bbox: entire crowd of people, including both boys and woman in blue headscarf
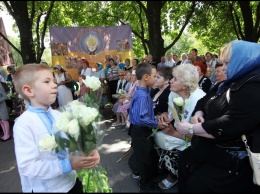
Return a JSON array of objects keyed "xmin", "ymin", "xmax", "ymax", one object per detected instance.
[{"xmin": 0, "ymin": 41, "xmax": 260, "ymax": 193}]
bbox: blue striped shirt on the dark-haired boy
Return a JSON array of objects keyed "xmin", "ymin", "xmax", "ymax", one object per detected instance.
[{"xmin": 129, "ymin": 86, "xmax": 158, "ymax": 128}]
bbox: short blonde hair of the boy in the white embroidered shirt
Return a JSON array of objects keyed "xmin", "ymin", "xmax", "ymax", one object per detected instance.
[{"xmin": 13, "ymin": 63, "xmax": 53, "ymax": 102}]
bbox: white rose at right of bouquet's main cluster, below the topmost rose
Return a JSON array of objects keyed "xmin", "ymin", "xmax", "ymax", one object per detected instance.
[{"xmin": 80, "ymin": 107, "xmax": 99, "ymax": 126}]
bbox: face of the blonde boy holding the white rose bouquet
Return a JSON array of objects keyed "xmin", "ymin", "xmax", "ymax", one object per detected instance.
[{"xmin": 30, "ymin": 70, "xmax": 58, "ymax": 110}]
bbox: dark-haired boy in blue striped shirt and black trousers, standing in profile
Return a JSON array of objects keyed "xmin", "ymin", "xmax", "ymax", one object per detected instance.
[{"xmin": 129, "ymin": 63, "xmax": 168, "ymax": 192}]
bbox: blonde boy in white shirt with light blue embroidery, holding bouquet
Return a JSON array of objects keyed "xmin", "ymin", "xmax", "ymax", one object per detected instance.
[{"xmin": 13, "ymin": 64, "xmax": 100, "ymax": 193}]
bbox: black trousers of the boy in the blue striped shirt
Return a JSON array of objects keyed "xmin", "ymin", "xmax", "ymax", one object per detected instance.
[{"xmin": 131, "ymin": 125, "xmax": 159, "ymax": 189}]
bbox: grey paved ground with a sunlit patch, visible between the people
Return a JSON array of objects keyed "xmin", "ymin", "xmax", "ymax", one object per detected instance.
[{"xmin": 0, "ymin": 109, "xmax": 177, "ymax": 193}]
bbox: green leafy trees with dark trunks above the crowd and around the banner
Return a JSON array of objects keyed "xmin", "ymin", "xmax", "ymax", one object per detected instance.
[{"xmin": 0, "ymin": 1, "xmax": 260, "ymax": 66}]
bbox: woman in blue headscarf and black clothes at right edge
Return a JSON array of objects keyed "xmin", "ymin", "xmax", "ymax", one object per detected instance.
[{"xmin": 174, "ymin": 40, "xmax": 260, "ymax": 193}]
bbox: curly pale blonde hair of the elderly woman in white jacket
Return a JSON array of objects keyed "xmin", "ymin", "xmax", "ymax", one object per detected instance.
[{"xmin": 172, "ymin": 64, "xmax": 199, "ymax": 93}]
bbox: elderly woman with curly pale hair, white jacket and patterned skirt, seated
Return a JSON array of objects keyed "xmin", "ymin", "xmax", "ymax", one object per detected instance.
[{"xmin": 155, "ymin": 64, "xmax": 206, "ymax": 189}]
